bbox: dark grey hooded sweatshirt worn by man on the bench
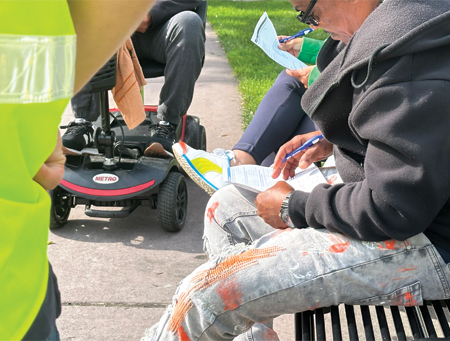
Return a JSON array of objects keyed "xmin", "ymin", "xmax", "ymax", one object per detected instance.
[{"xmin": 289, "ymin": 0, "xmax": 450, "ymax": 251}]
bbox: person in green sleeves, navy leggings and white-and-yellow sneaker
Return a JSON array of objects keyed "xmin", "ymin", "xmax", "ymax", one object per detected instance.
[{"xmin": 172, "ymin": 36, "xmax": 331, "ymax": 195}]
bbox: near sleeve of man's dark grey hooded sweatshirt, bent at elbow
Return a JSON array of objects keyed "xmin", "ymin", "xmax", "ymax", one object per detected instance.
[{"xmin": 289, "ymin": 79, "xmax": 450, "ymax": 241}]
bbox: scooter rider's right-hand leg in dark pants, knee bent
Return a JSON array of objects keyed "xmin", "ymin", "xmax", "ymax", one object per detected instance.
[{"xmin": 132, "ymin": 11, "xmax": 205, "ymax": 124}]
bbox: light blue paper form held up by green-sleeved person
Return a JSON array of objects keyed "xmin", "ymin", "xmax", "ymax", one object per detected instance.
[{"xmin": 252, "ymin": 12, "xmax": 306, "ymax": 70}]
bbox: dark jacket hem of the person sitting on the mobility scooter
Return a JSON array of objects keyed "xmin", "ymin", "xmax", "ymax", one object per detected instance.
[{"xmin": 148, "ymin": 0, "xmax": 202, "ymax": 30}]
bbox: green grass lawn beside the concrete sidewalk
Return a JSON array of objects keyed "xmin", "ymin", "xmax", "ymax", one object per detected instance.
[{"xmin": 208, "ymin": 0, "xmax": 327, "ymax": 129}]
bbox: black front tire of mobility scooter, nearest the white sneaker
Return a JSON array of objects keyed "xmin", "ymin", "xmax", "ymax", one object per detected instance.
[{"xmin": 158, "ymin": 172, "xmax": 188, "ymax": 232}]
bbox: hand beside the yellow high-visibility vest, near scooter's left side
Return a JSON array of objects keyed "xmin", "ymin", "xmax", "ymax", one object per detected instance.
[{"xmin": 33, "ymin": 131, "xmax": 66, "ymax": 190}]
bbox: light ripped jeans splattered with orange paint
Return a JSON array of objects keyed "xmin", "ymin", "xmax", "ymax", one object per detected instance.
[{"xmin": 143, "ymin": 186, "xmax": 450, "ymax": 341}]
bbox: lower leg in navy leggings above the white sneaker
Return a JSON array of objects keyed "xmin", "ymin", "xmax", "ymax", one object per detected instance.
[{"xmin": 232, "ymin": 70, "xmax": 314, "ymax": 164}]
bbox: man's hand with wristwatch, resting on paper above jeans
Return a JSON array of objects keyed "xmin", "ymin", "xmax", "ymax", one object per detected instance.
[{"xmin": 255, "ymin": 181, "xmax": 294, "ymax": 229}]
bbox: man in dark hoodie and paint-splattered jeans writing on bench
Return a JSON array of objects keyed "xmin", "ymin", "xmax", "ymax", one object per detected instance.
[{"xmin": 142, "ymin": 0, "xmax": 450, "ymax": 341}]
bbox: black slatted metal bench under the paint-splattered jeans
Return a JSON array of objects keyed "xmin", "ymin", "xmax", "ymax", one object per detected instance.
[{"xmin": 295, "ymin": 300, "xmax": 450, "ymax": 341}]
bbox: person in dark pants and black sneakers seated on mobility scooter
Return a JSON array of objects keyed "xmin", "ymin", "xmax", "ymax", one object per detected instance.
[{"xmin": 62, "ymin": 0, "xmax": 205, "ymax": 151}]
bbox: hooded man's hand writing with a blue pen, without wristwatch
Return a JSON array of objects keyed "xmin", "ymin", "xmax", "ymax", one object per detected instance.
[{"xmin": 272, "ymin": 130, "xmax": 333, "ymax": 180}]
